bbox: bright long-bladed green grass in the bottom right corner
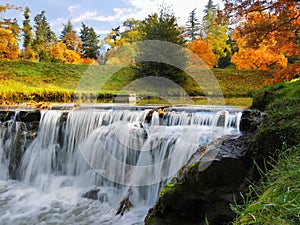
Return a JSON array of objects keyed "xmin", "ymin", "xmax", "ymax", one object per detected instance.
[{"xmin": 233, "ymin": 145, "xmax": 300, "ymax": 225}]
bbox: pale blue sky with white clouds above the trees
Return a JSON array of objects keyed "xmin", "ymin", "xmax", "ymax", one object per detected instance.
[{"xmin": 4, "ymin": 0, "xmax": 222, "ymax": 38}]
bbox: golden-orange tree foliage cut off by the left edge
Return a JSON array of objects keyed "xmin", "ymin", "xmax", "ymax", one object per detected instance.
[{"xmin": 0, "ymin": 27, "xmax": 20, "ymax": 59}]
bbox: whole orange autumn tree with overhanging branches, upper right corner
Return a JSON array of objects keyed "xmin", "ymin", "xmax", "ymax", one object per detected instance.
[{"xmin": 224, "ymin": 0, "xmax": 300, "ymax": 78}]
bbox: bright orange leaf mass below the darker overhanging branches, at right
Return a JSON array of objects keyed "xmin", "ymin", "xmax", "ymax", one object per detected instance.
[{"xmin": 231, "ymin": 12, "xmax": 299, "ymax": 70}]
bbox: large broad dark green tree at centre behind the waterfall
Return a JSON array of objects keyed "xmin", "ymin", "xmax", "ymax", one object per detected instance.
[{"xmin": 136, "ymin": 7, "xmax": 187, "ymax": 83}]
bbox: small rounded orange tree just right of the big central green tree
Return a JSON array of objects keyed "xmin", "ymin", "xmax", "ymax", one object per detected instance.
[{"xmin": 188, "ymin": 39, "xmax": 217, "ymax": 68}]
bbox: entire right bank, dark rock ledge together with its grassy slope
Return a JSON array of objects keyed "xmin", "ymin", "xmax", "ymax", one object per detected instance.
[{"xmin": 145, "ymin": 80, "xmax": 300, "ymax": 225}]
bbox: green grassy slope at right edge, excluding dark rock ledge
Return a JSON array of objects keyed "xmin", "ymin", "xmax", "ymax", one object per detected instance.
[{"xmin": 233, "ymin": 79, "xmax": 300, "ymax": 225}]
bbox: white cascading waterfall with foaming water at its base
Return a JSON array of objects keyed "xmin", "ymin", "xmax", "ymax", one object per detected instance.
[{"xmin": 0, "ymin": 109, "xmax": 241, "ymax": 225}]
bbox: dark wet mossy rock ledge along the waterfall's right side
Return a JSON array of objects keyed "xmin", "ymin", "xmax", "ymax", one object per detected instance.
[{"xmin": 145, "ymin": 110, "xmax": 262, "ymax": 225}]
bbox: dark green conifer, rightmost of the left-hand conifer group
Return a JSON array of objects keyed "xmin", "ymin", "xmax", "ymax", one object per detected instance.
[{"xmin": 80, "ymin": 23, "xmax": 100, "ymax": 59}]
